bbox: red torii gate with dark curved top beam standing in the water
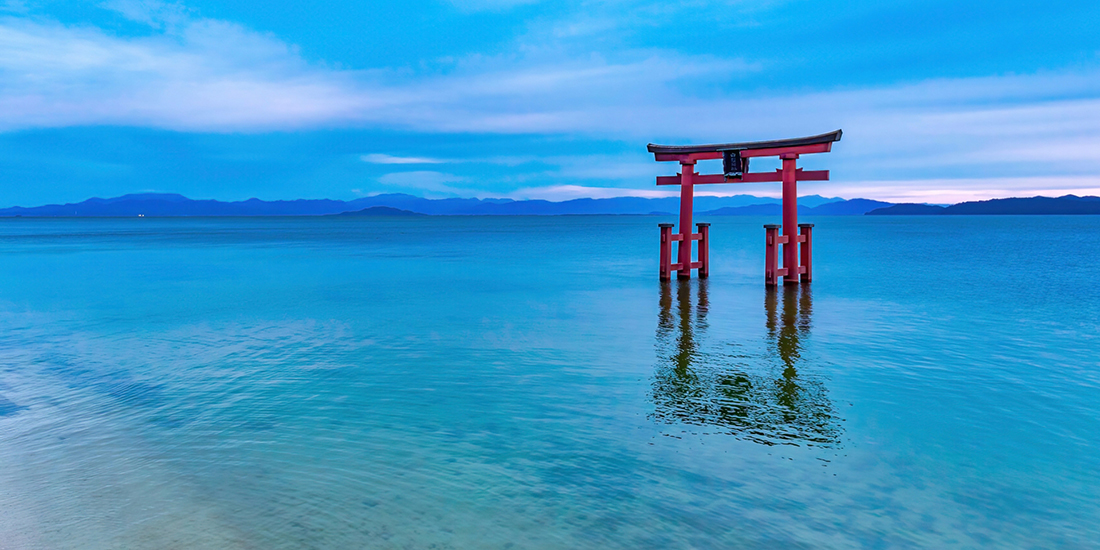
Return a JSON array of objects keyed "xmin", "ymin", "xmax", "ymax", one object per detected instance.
[{"xmin": 648, "ymin": 130, "xmax": 843, "ymax": 285}]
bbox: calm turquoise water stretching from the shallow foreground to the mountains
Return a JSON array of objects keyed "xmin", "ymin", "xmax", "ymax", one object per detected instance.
[{"xmin": 0, "ymin": 217, "xmax": 1100, "ymax": 549}]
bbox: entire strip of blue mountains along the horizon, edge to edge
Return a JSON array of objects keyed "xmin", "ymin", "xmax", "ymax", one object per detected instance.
[{"xmin": 0, "ymin": 194, "xmax": 1100, "ymax": 218}]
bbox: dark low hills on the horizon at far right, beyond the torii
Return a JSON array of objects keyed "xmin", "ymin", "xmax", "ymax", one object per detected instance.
[{"xmin": 867, "ymin": 195, "xmax": 1100, "ymax": 216}]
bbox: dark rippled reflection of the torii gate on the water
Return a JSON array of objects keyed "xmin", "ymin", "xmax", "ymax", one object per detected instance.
[{"xmin": 652, "ymin": 279, "xmax": 840, "ymax": 446}]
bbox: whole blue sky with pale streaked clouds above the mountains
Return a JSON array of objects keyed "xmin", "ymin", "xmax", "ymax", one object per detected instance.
[{"xmin": 0, "ymin": 0, "xmax": 1100, "ymax": 206}]
